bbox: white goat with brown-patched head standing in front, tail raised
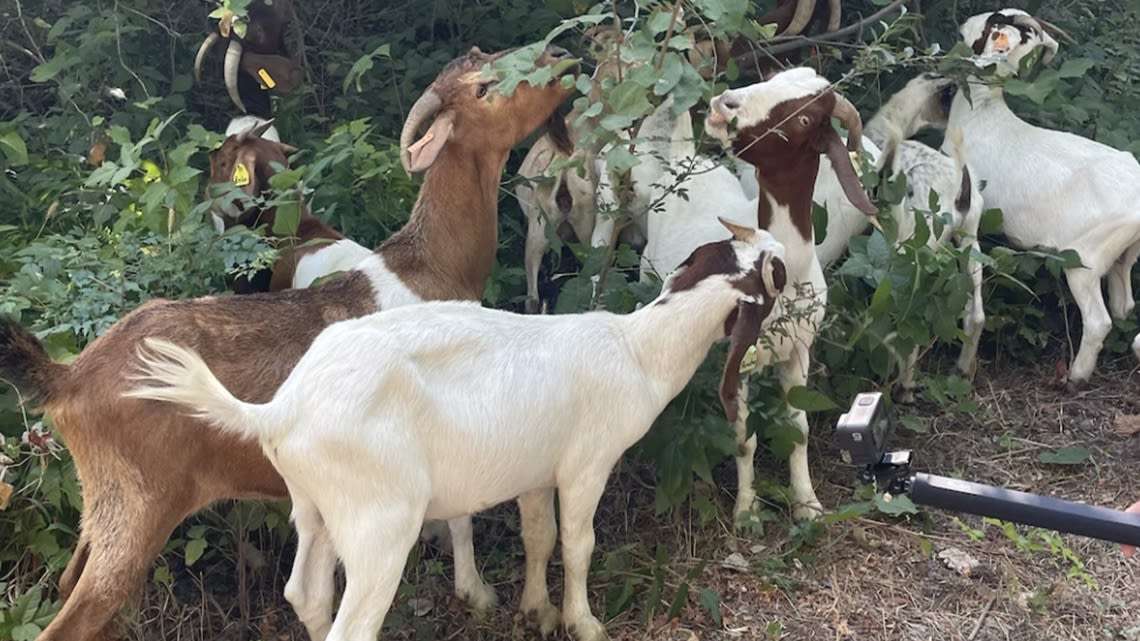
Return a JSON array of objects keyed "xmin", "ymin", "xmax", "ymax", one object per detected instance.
[{"xmin": 127, "ymin": 217, "xmax": 784, "ymax": 641}]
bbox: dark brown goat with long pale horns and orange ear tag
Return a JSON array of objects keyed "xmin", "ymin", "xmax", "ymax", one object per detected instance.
[{"xmin": 194, "ymin": 0, "xmax": 304, "ymax": 117}]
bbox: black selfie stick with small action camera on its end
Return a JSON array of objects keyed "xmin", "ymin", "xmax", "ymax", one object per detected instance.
[{"xmin": 836, "ymin": 392, "xmax": 1140, "ymax": 546}]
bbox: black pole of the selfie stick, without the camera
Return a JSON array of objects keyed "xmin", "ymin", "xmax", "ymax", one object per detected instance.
[{"xmin": 906, "ymin": 472, "xmax": 1140, "ymax": 545}]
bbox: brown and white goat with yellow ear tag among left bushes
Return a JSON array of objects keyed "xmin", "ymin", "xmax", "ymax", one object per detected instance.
[{"xmin": 206, "ymin": 121, "xmax": 372, "ymax": 293}]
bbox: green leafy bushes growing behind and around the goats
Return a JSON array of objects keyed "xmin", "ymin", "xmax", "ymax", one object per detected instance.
[{"xmin": 0, "ymin": 0, "xmax": 1140, "ymax": 640}]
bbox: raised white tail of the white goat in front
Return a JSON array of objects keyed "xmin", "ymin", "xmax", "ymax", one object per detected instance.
[{"xmin": 123, "ymin": 338, "xmax": 277, "ymax": 439}]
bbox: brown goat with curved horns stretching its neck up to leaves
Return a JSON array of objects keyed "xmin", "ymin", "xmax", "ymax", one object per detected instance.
[{"xmin": 0, "ymin": 47, "xmax": 570, "ymax": 641}]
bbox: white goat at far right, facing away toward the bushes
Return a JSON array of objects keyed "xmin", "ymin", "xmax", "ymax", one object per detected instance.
[{"xmin": 943, "ymin": 9, "xmax": 1140, "ymax": 384}]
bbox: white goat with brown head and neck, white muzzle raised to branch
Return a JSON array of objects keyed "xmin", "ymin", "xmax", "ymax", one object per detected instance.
[{"xmin": 642, "ymin": 68, "xmax": 874, "ymax": 521}]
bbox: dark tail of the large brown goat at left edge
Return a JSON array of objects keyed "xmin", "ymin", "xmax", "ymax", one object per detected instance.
[{"xmin": 0, "ymin": 316, "xmax": 70, "ymax": 406}]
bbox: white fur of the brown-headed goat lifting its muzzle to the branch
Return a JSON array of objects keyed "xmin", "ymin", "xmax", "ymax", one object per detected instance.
[{"xmin": 635, "ymin": 68, "xmax": 866, "ymax": 521}]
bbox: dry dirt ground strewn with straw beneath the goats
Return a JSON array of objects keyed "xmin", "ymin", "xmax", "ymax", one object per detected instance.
[{"xmin": 130, "ymin": 346, "xmax": 1140, "ymax": 641}]
